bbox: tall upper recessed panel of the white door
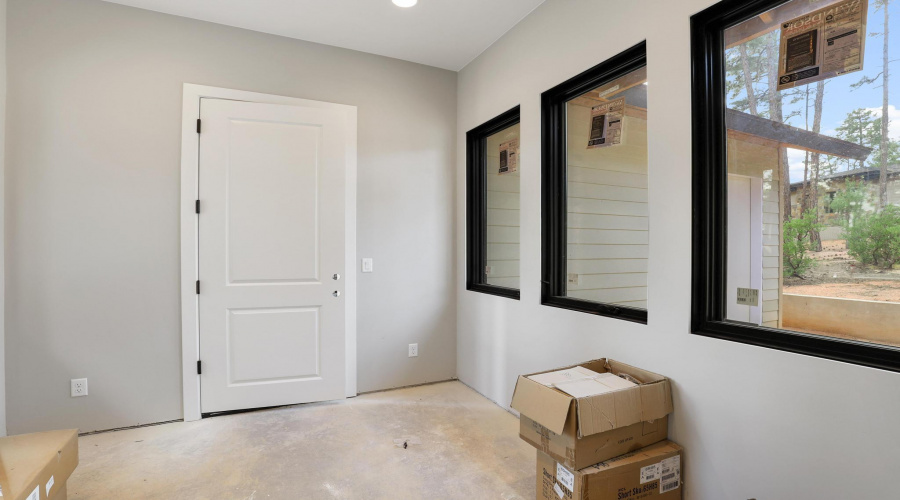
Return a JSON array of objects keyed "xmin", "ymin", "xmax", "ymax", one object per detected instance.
[{"xmin": 226, "ymin": 119, "xmax": 322, "ymax": 284}]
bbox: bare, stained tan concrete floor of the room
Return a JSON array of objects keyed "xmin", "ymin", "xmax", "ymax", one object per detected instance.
[{"xmin": 68, "ymin": 382, "xmax": 535, "ymax": 500}]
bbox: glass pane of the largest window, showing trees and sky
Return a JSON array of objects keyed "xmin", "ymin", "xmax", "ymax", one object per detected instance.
[{"xmin": 725, "ymin": 0, "xmax": 900, "ymax": 346}]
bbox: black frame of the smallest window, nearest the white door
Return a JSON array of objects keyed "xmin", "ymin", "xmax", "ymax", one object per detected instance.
[{"xmin": 466, "ymin": 106, "xmax": 521, "ymax": 300}]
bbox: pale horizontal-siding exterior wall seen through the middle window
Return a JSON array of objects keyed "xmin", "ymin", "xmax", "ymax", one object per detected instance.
[{"xmin": 566, "ymin": 108, "xmax": 650, "ymax": 308}]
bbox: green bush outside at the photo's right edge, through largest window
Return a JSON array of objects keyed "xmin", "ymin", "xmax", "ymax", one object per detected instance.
[{"xmin": 845, "ymin": 205, "xmax": 900, "ymax": 269}]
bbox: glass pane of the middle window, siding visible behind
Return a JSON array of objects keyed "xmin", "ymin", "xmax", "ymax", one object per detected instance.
[{"xmin": 565, "ymin": 67, "xmax": 649, "ymax": 309}]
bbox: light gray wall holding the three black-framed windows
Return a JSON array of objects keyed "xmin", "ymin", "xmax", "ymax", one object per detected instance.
[{"xmin": 456, "ymin": 0, "xmax": 900, "ymax": 500}]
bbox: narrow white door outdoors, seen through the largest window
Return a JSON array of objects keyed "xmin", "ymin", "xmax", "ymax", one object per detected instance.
[{"xmin": 726, "ymin": 175, "xmax": 763, "ymax": 325}]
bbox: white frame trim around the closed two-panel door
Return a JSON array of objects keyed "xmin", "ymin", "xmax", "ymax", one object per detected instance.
[{"xmin": 181, "ymin": 83, "xmax": 357, "ymax": 421}]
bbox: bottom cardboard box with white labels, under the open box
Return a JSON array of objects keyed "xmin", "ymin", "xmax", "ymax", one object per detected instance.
[{"xmin": 537, "ymin": 441, "xmax": 683, "ymax": 500}]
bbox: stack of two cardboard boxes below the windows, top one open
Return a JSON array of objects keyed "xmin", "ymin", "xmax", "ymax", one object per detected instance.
[{"xmin": 511, "ymin": 358, "xmax": 681, "ymax": 500}]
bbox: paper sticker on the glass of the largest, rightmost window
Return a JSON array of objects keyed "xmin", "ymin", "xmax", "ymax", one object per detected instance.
[{"xmin": 778, "ymin": 0, "xmax": 869, "ymax": 90}]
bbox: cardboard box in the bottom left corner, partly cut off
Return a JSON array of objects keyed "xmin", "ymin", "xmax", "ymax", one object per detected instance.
[{"xmin": 0, "ymin": 429, "xmax": 78, "ymax": 500}]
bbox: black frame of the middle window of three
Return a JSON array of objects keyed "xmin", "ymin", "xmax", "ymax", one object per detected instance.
[{"xmin": 541, "ymin": 41, "xmax": 649, "ymax": 324}]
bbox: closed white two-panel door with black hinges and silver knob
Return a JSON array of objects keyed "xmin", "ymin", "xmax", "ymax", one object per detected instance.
[{"xmin": 198, "ymin": 98, "xmax": 349, "ymax": 413}]
